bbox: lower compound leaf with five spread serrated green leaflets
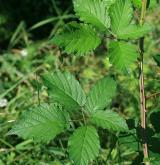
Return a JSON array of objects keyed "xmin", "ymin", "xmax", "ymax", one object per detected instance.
[{"xmin": 9, "ymin": 72, "xmax": 128, "ymax": 164}]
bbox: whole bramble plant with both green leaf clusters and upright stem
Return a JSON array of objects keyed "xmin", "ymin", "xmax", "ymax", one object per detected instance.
[{"xmin": 9, "ymin": 0, "xmax": 158, "ymax": 165}]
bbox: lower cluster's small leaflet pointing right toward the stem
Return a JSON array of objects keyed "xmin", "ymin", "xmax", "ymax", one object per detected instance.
[{"xmin": 90, "ymin": 110, "xmax": 128, "ymax": 131}]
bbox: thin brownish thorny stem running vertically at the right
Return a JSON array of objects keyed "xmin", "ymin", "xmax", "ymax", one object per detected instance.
[{"xmin": 139, "ymin": 0, "xmax": 150, "ymax": 165}]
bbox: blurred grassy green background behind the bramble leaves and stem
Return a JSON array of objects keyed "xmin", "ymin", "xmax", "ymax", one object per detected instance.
[{"xmin": 0, "ymin": 0, "xmax": 160, "ymax": 165}]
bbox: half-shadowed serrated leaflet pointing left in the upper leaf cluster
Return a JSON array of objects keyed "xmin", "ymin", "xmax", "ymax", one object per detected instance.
[{"xmin": 53, "ymin": 23, "xmax": 101, "ymax": 55}]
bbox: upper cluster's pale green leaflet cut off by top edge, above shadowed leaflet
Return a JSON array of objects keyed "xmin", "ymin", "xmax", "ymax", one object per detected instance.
[{"xmin": 74, "ymin": 0, "xmax": 110, "ymax": 31}]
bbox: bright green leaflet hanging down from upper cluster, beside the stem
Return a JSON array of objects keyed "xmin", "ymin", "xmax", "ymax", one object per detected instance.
[{"xmin": 109, "ymin": 41, "xmax": 138, "ymax": 72}]
